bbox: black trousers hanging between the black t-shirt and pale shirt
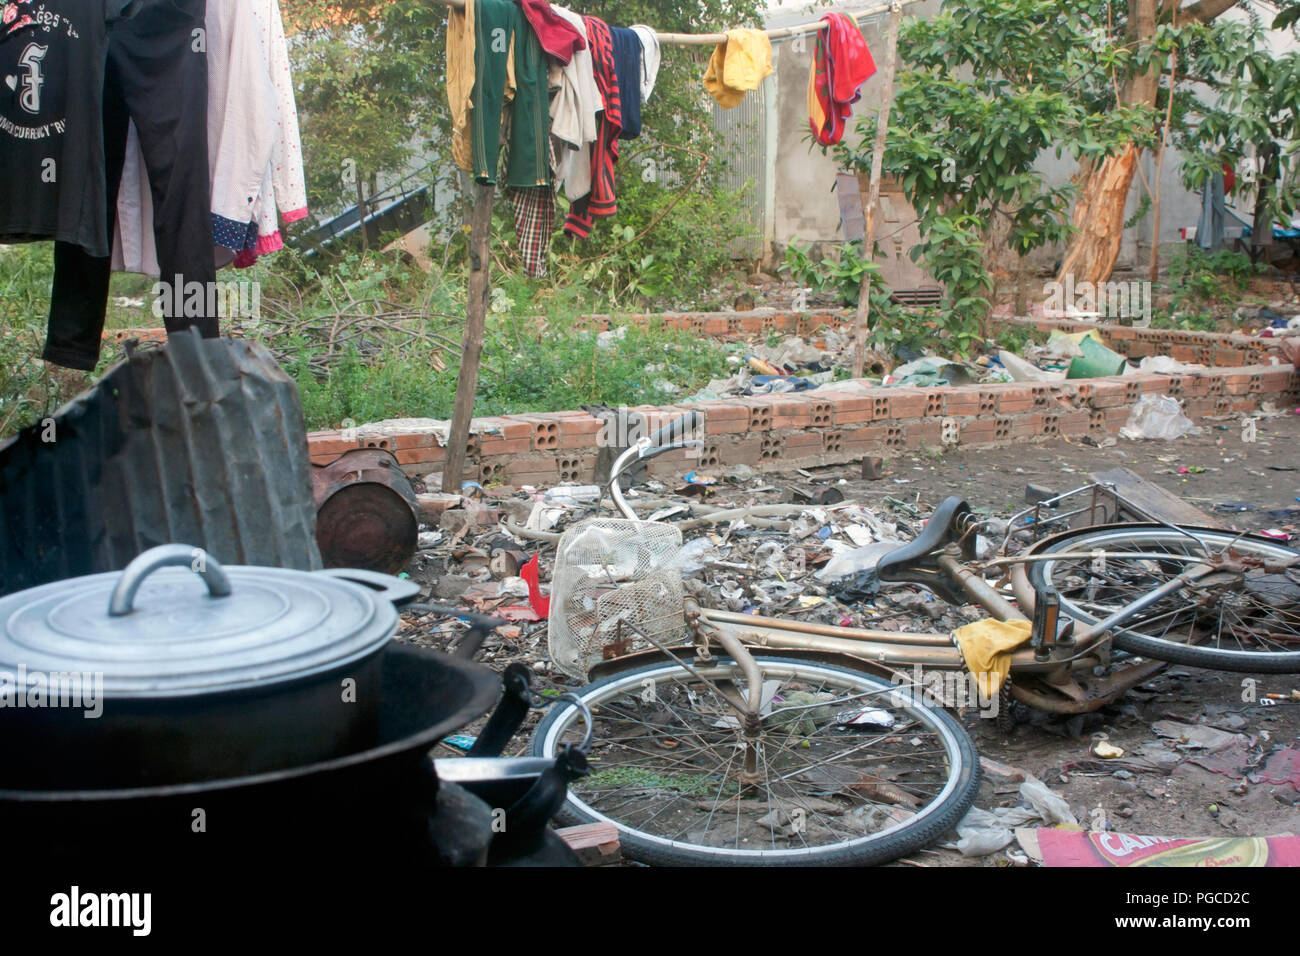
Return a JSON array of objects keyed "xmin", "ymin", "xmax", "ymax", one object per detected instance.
[{"xmin": 43, "ymin": 0, "xmax": 218, "ymax": 371}]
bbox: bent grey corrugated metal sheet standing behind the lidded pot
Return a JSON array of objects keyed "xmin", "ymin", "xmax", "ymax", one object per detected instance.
[{"xmin": 0, "ymin": 332, "xmax": 321, "ymax": 594}]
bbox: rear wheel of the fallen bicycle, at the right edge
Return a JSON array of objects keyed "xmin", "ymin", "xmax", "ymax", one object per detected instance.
[{"xmin": 1028, "ymin": 524, "xmax": 1300, "ymax": 674}]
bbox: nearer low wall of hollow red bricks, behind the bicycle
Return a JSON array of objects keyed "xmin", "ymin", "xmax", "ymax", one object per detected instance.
[{"xmin": 308, "ymin": 356, "xmax": 1300, "ymax": 486}]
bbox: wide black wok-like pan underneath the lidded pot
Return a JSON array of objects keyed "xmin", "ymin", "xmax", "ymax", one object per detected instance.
[{"xmin": 0, "ymin": 641, "xmax": 501, "ymax": 868}]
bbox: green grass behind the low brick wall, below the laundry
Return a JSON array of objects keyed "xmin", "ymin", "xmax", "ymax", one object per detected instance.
[{"xmin": 0, "ymin": 243, "xmax": 728, "ymax": 436}]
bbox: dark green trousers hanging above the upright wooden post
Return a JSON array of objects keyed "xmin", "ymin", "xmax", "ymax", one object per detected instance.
[{"xmin": 469, "ymin": 0, "xmax": 551, "ymax": 186}]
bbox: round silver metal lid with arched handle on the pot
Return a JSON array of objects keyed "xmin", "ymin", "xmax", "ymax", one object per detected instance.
[{"xmin": 0, "ymin": 545, "xmax": 406, "ymax": 698}]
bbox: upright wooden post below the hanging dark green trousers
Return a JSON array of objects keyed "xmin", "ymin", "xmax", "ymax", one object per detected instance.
[{"xmin": 442, "ymin": 183, "xmax": 497, "ymax": 494}]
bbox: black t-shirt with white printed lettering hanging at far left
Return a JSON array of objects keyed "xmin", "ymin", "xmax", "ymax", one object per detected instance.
[{"xmin": 0, "ymin": 0, "xmax": 138, "ymax": 256}]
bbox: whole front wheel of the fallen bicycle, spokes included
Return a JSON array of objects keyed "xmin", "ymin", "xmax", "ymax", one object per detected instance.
[{"xmin": 533, "ymin": 650, "xmax": 979, "ymax": 866}]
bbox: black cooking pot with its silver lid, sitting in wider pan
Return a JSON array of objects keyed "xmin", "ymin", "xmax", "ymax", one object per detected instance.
[{"xmin": 0, "ymin": 545, "xmax": 419, "ymax": 790}]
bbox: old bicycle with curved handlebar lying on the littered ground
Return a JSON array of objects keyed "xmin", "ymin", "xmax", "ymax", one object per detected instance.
[{"xmin": 532, "ymin": 415, "xmax": 1300, "ymax": 865}]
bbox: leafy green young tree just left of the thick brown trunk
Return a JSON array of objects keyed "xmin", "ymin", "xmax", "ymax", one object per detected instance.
[{"xmin": 836, "ymin": 0, "xmax": 1152, "ymax": 349}]
